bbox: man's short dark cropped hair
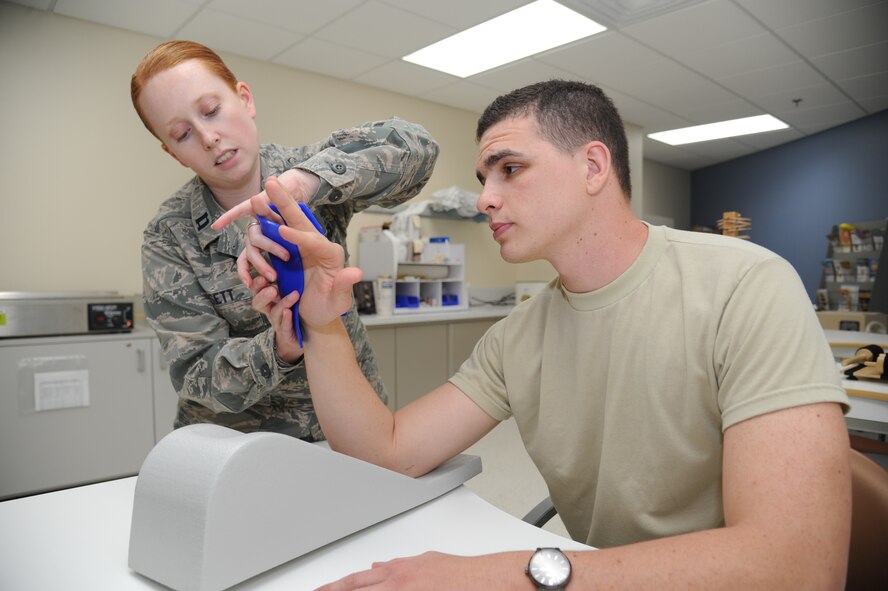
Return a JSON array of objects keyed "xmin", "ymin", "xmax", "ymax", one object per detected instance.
[{"xmin": 475, "ymin": 80, "xmax": 632, "ymax": 197}]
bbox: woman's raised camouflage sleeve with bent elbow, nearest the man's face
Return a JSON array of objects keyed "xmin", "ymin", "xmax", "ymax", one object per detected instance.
[{"xmin": 282, "ymin": 117, "xmax": 439, "ymax": 211}]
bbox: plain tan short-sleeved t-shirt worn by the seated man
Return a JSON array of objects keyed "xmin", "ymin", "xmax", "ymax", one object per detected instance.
[{"xmin": 450, "ymin": 227, "xmax": 848, "ymax": 548}]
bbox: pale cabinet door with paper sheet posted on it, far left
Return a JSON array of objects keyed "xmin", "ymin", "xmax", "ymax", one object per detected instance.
[{"xmin": 0, "ymin": 335, "xmax": 155, "ymax": 499}]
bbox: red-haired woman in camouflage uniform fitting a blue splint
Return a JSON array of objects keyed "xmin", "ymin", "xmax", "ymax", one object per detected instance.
[{"xmin": 131, "ymin": 41, "xmax": 438, "ymax": 441}]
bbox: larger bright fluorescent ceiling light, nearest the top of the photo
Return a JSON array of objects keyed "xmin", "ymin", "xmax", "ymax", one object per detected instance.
[{"xmin": 401, "ymin": 0, "xmax": 605, "ymax": 78}]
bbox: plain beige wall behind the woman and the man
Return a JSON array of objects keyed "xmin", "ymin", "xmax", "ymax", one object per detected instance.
[{"xmin": 0, "ymin": 2, "xmax": 688, "ymax": 294}]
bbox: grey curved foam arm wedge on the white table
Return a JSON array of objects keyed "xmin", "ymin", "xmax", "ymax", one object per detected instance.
[{"xmin": 129, "ymin": 425, "xmax": 481, "ymax": 591}]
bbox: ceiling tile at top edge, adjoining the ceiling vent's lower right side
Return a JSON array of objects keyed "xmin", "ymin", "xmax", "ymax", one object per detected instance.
[{"xmin": 623, "ymin": 0, "xmax": 765, "ymax": 54}]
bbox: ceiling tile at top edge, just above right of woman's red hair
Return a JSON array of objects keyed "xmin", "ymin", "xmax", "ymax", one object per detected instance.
[{"xmin": 206, "ymin": 0, "xmax": 364, "ymax": 34}]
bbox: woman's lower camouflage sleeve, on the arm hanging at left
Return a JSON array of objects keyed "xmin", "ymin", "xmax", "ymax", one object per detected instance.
[{"xmin": 142, "ymin": 219, "xmax": 287, "ymax": 412}]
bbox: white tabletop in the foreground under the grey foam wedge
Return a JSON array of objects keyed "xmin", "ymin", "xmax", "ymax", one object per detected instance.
[{"xmin": 0, "ymin": 477, "xmax": 588, "ymax": 591}]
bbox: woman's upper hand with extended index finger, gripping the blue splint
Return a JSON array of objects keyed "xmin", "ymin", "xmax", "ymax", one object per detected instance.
[{"xmin": 212, "ymin": 168, "xmax": 321, "ymax": 289}]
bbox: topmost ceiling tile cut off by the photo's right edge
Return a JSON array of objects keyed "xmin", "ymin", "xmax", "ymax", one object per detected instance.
[{"xmin": 777, "ymin": 2, "xmax": 888, "ymax": 57}]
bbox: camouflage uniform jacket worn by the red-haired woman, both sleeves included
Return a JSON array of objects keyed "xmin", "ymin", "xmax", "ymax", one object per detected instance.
[{"xmin": 142, "ymin": 118, "xmax": 438, "ymax": 441}]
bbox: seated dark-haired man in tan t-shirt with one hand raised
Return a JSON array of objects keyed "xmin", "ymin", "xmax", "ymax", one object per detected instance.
[{"xmin": 222, "ymin": 81, "xmax": 851, "ymax": 591}]
